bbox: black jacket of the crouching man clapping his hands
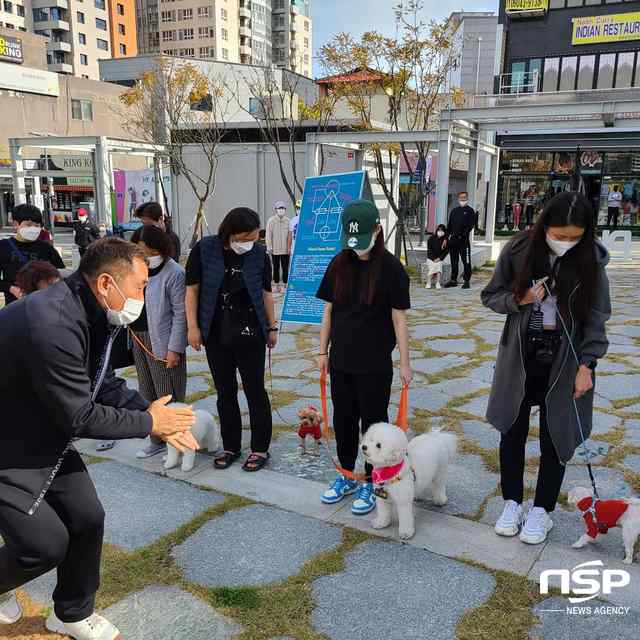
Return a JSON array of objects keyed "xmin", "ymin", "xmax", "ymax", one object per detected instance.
[{"xmin": 0, "ymin": 272, "xmax": 152, "ymax": 512}]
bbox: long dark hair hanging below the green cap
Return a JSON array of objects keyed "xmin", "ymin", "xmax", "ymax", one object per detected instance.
[{"xmin": 331, "ymin": 230, "xmax": 386, "ymax": 306}]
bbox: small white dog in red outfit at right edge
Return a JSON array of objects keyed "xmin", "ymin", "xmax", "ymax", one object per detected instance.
[{"xmin": 568, "ymin": 487, "xmax": 640, "ymax": 564}]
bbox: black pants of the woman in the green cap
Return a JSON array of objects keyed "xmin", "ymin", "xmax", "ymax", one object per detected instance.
[{"xmin": 331, "ymin": 369, "xmax": 393, "ymax": 481}]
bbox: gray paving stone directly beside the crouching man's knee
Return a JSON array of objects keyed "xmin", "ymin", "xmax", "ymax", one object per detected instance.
[{"xmin": 89, "ymin": 462, "xmax": 224, "ymax": 551}]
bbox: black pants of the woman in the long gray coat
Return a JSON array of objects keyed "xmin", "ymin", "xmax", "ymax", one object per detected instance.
[{"xmin": 500, "ymin": 357, "xmax": 565, "ymax": 512}]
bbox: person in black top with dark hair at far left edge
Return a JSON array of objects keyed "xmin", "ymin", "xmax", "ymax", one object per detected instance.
[{"xmin": 0, "ymin": 204, "xmax": 64, "ymax": 304}]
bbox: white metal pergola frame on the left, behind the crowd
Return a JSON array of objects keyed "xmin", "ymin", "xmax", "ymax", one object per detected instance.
[{"xmin": 9, "ymin": 136, "xmax": 166, "ymax": 227}]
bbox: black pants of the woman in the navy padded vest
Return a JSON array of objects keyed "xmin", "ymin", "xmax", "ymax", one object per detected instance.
[{"xmin": 206, "ymin": 332, "xmax": 273, "ymax": 453}]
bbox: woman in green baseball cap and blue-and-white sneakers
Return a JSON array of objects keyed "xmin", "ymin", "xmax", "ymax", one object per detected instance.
[{"xmin": 316, "ymin": 200, "xmax": 413, "ymax": 515}]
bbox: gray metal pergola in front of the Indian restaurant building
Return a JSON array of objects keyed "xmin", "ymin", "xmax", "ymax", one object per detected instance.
[{"xmin": 306, "ymin": 95, "xmax": 640, "ymax": 252}]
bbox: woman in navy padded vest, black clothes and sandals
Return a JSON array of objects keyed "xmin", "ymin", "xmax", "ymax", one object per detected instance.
[{"xmin": 186, "ymin": 207, "xmax": 278, "ymax": 471}]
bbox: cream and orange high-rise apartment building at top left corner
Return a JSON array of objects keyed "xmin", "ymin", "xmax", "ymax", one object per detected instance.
[{"xmin": 0, "ymin": 0, "xmax": 137, "ymax": 80}]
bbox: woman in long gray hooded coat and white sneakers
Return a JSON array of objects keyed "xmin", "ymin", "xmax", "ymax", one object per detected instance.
[{"xmin": 482, "ymin": 193, "xmax": 611, "ymax": 544}]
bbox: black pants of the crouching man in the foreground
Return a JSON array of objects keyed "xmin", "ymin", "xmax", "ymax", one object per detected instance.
[{"xmin": 0, "ymin": 452, "xmax": 104, "ymax": 622}]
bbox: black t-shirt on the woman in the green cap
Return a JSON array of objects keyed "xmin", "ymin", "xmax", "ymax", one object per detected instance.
[{"xmin": 316, "ymin": 251, "xmax": 411, "ymax": 373}]
